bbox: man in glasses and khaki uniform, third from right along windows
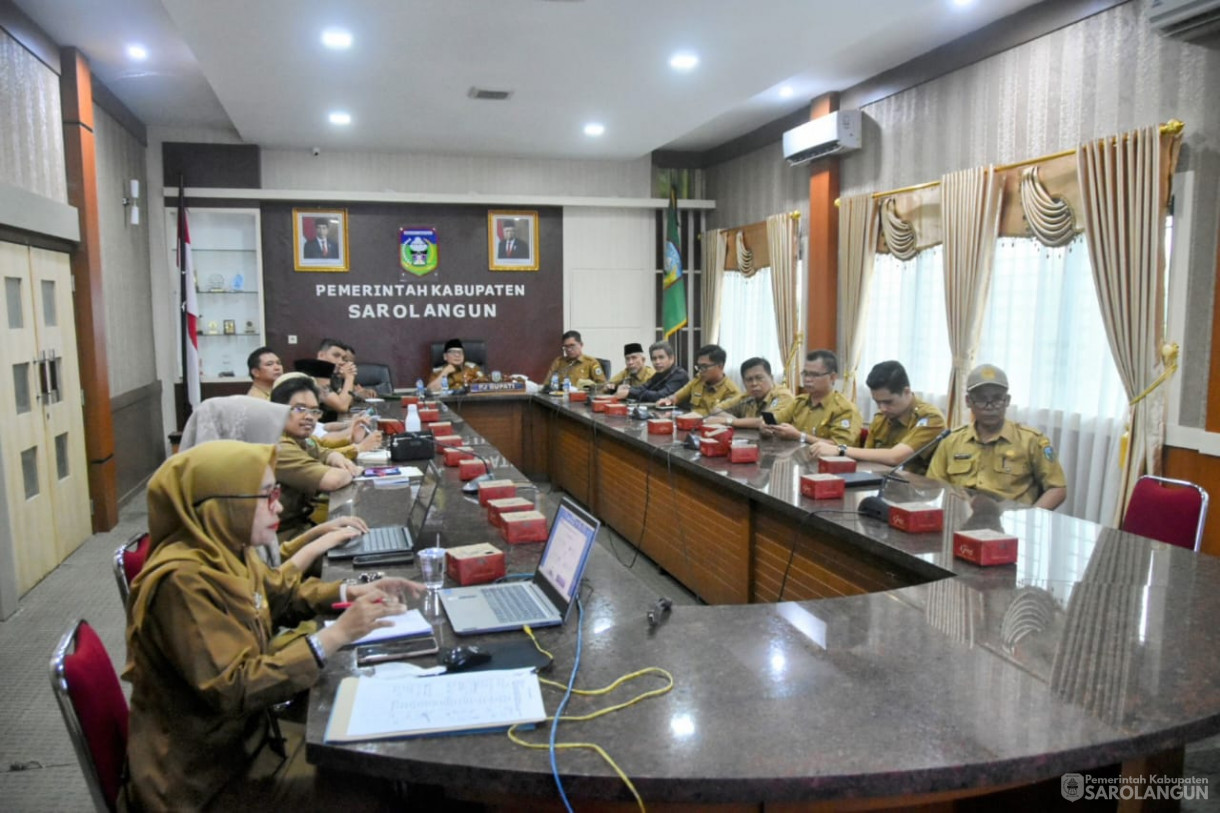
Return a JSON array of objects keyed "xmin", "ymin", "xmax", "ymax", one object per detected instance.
[{"xmin": 759, "ymin": 350, "xmax": 864, "ymax": 446}]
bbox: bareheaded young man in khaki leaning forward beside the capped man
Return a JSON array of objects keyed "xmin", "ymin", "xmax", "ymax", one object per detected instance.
[{"xmin": 814, "ymin": 361, "xmax": 944, "ymax": 474}]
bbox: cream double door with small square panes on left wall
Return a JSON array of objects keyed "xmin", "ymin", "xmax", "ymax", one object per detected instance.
[{"xmin": 0, "ymin": 243, "xmax": 92, "ymax": 594}]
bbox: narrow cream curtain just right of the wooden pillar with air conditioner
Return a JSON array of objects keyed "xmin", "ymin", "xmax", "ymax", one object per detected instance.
[{"xmin": 838, "ymin": 194, "xmax": 880, "ymax": 400}]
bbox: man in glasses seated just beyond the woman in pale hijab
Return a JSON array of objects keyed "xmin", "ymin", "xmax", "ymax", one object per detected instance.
[{"xmin": 271, "ymin": 374, "xmax": 361, "ymax": 537}]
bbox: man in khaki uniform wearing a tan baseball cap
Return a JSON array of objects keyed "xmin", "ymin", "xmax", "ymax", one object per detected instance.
[{"xmin": 927, "ymin": 364, "xmax": 1068, "ymax": 510}]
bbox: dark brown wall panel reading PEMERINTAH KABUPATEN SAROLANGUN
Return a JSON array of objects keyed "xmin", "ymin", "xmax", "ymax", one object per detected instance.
[{"xmin": 262, "ymin": 201, "xmax": 564, "ymax": 386}]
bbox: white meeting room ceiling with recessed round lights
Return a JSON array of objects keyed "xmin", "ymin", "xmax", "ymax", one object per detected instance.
[{"xmin": 16, "ymin": 0, "xmax": 1036, "ymax": 159}]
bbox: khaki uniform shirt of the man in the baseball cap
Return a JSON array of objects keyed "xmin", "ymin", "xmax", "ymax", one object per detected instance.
[{"xmin": 927, "ymin": 421, "xmax": 1068, "ymax": 504}]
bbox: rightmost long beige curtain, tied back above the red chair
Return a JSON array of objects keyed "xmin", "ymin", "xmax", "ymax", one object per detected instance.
[{"xmin": 1076, "ymin": 127, "xmax": 1181, "ymax": 524}]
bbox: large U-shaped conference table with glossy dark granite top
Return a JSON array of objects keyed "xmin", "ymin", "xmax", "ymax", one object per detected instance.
[{"xmin": 307, "ymin": 396, "xmax": 1220, "ymax": 809}]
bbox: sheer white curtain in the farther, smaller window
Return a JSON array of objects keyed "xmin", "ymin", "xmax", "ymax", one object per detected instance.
[{"xmin": 717, "ymin": 267, "xmax": 783, "ymax": 385}]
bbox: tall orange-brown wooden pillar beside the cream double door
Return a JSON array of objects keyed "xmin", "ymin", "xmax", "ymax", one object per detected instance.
[{"xmin": 60, "ymin": 48, "xmax": 118, "ymax": 531}]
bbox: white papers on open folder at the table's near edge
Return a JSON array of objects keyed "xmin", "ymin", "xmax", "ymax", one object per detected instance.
[{"xmin": 326, "ymin": 669, "xmax": 547, "ymax": 742}]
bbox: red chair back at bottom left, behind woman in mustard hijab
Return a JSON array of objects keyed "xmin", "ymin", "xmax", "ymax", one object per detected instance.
[{"xmin": 51, "ymin": 620, "xmax": 128, "ymax": 811}]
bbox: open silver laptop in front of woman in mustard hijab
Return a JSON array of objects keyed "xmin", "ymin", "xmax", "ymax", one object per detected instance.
[{"xmin": 440, "ymin": 498, "xmax": 601, "ymax": 635}]
